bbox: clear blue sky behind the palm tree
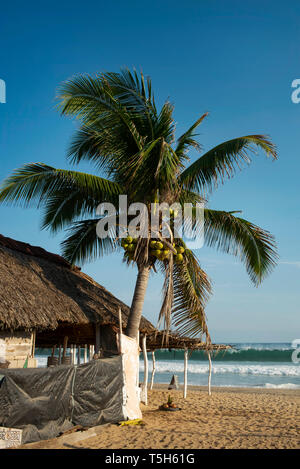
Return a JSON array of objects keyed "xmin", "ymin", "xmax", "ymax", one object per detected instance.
[{"xmin": 0, "ymin": 0, "xmax": 300, "ymax": 342}]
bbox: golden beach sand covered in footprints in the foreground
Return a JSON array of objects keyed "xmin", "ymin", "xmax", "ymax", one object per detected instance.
[{"xmin": 22, "ymin": 386, "xmax": 300, "ymax": 449}]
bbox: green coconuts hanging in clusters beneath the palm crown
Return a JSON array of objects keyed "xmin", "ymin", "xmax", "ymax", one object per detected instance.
[{"xmin": 121, "ymin": 236, "xmax": 185, "ymax": 263}]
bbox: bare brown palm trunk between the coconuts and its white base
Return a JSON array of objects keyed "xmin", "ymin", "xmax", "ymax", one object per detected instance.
[{"xmin": 126, "ymin": 266, "xmax": 150, "ymax": 339}]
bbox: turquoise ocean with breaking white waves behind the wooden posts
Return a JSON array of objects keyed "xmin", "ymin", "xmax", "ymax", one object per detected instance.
[{"xmin": 36, "ymin": 343, "xmax": 300, "ymax": 389}]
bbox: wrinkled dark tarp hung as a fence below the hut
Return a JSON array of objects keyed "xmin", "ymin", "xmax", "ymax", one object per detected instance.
[{"xmin": 0, "ymin": 355, "xmax": 125, "ymax": 443}]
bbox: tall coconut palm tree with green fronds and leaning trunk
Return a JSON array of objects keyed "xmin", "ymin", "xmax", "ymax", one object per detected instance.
[{"xmin": 0, "ymin": 69, "xmax": 277, "ymax": 340}]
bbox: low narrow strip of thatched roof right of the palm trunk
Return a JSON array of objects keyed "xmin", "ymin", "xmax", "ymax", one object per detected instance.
[{"xmin": 146, "ymin": 331, "xmax": 231, "ymax": 351}]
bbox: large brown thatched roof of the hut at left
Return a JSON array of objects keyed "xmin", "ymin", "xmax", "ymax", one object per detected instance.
[{"xmin": 0, "ymin": 235, "xmax": 155, "ymax": 333}]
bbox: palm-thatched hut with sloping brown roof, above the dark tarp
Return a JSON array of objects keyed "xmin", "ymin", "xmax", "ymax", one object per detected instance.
[{"xmin": 0, "ymin": 235, "xmax": 155, "ymax": 368}]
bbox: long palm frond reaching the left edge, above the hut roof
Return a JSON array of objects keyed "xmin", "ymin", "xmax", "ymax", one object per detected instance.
[{"xmin": 0, "ymin": 163, "xmax": 123, "ymax": 231}]
